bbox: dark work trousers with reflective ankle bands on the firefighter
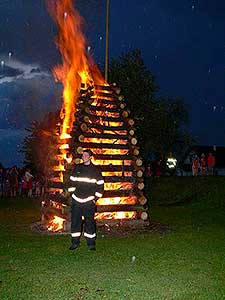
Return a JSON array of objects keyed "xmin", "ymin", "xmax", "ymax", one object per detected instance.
[{"xmin": 71, "ymin": 200, "xmax": 96, "ymax": 246}]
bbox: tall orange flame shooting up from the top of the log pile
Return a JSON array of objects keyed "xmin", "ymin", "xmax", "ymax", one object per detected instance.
[{"xmin": 47, "ymin": 0, "xmax": 104, "ymax": 135}]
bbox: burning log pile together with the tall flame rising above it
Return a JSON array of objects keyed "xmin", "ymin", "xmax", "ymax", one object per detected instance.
[{"xmin": 42, "ymin": 0, "xmax": 148, "ymax": 231}]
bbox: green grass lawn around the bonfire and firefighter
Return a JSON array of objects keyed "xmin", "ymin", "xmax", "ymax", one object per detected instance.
[{"xmin": 0, "ymin": 178, "xmax": 225, "ymax": 300}]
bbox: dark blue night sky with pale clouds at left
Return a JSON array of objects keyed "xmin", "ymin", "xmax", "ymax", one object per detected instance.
[{"xmin": 0, "ymin": 0, "xmax": 225, "ymax": 167}]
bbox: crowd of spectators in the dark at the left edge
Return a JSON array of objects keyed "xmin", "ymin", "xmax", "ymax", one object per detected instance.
[{"xmin": 0, "ymin": 166, "xmax": 46, "ymax": 197}]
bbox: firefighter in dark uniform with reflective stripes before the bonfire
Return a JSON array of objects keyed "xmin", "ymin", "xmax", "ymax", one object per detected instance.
[{"xmin": 68, "ymin": 149, "xmax": 104, "ymax": 250}]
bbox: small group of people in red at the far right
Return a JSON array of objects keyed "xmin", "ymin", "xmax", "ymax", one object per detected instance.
[{"xmin": 192, "ymin": 153, "xmax": 216, "ymax": 176}]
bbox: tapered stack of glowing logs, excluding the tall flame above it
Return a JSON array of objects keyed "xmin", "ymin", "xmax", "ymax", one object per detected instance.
[{"xmin": 42, "ymin": 85, "xmax": 148, "ymax": 230}]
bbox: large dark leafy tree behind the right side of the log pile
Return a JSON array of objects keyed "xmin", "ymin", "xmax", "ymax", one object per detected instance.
[{"xmin": 109, "ymin": 50, "xmax": 190, "ymax": 157}]
